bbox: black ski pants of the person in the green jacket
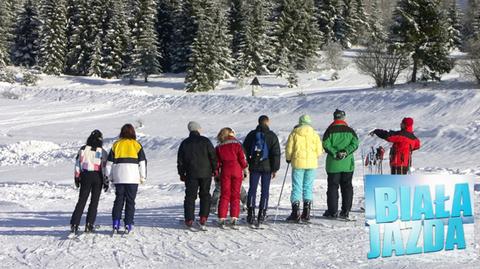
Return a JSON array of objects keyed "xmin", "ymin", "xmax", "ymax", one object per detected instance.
[{"xmin": 327, "ymin": 172, "xmax": 353, "ymax": 215}]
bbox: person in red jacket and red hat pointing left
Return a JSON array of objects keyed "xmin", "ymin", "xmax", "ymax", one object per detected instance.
[{"xmin": 370, "ymin": 118, "xmax": 420, "ymax": 175}]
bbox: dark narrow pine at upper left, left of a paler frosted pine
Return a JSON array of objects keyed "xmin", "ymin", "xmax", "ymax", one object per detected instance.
[{"xmin": 12, "ymin": 0, "xmax": 40, "ymax": 67}]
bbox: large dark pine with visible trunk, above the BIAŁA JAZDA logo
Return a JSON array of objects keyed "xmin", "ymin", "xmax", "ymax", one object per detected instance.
[{"xmin": 390, "ymin": 0, "xmax": 453, "ymax": 82}]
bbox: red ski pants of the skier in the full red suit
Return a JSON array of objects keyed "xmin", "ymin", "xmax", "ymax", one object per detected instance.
[{"xmin": 218, "ymin": 169, "xmax": 243, "ymax": 219}]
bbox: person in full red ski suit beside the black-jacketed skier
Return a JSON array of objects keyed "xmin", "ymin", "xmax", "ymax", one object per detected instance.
[{"xmin": 216, "ymin": 127, "xmax": 247, "ymax": 228}]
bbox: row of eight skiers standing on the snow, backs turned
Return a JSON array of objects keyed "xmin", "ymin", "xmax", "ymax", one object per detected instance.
[{"xmin": 70, "ymin": 109, "xmax": 420, "ymax": 233}]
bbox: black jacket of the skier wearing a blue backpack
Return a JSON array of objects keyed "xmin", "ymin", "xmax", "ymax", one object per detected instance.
[{"xmin": 243, "ymin": 125, "xmax": 281, "ymax": 173}]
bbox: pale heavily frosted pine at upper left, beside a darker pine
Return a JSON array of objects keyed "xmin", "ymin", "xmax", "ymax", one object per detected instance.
[{"xmin": 39, "ymin": 0, "xmax": 67, "ymax": 75}]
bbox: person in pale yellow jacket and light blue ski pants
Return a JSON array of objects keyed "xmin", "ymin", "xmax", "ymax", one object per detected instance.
[{"xmin": 285, "ymin": 115, "xmax": 323, "ymax": 222}]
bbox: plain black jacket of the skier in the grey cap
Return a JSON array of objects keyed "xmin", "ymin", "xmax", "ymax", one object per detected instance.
[{"xmin": 177, "ymin": 131, "xmax": 217, "ymax": 179}]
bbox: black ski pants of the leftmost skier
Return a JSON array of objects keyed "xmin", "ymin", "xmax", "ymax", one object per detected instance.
[{"xmin": 70, "ymin": 171, "xmax": 103, "ymax": 225}]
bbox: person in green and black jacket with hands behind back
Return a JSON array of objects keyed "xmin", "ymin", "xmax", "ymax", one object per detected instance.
[{"xmin": 323, "ymin": 109, "xmax": 359, "ymax": 219}]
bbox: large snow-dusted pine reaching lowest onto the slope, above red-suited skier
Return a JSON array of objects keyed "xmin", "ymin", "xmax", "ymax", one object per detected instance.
[{"xmin": 185, "ymin": 0, "xmax": 231, "ymax": 92}]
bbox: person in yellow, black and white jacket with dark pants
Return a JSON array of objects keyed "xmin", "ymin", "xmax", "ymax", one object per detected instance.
[{"xmin": 106, "ymin": 124, "xmax": 147, "ymax": 233}]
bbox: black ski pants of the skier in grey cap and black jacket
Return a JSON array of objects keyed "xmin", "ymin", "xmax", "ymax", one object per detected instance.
[{"xmin": 183, "ymin": 178, "xmax": 212, "ymax": 221}]
